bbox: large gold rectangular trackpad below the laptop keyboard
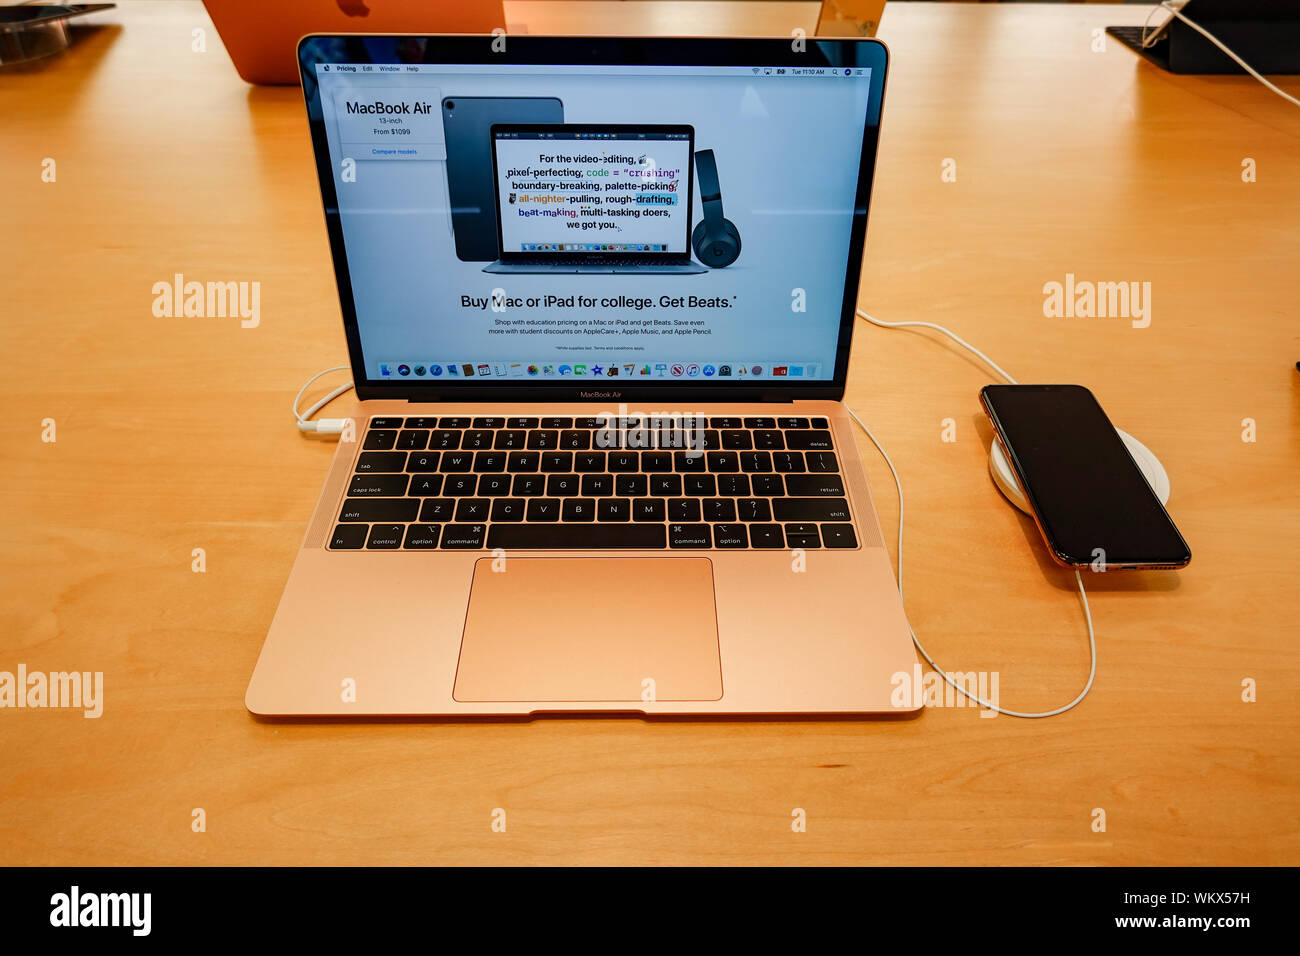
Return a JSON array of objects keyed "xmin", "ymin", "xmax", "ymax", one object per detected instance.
[{"xmin": 452, "ymin": 557, "xmax": 723, "ymax": 704}]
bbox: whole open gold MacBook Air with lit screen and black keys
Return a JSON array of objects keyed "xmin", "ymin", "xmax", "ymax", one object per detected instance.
[{"xmin": 246, "ymin": 35, "xmax": 917, "ymax": 718}]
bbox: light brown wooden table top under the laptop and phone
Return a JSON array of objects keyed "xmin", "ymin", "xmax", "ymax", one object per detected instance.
[{"xmin": 0, "ymin": 0, "xmax": 1300, "ymax": 865}]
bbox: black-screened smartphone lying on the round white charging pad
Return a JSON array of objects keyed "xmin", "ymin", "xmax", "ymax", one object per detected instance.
[{"xmin": 980, "ymin": 385, "xmax": 1192, "ymax": 570}]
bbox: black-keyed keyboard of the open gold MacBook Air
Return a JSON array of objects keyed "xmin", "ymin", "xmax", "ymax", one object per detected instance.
[{"xmin": 329, "ymin": 416, "xmax": 858, "ymax": 550}]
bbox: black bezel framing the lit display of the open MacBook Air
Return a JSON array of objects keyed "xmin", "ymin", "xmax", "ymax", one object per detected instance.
[{"xmin": 298, "ymin": 34, "xmax": 888, "ymax": 405}]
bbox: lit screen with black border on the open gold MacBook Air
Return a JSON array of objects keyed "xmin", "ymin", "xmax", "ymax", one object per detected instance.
[{"xmin": 303, "ymin": 46, "xmax": 883, "ymax": 395}]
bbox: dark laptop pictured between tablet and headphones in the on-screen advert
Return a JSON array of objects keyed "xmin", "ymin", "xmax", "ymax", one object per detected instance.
[{"xmin": 484, "ymin": 124, "xmax": 707, "ymax": 274}]
